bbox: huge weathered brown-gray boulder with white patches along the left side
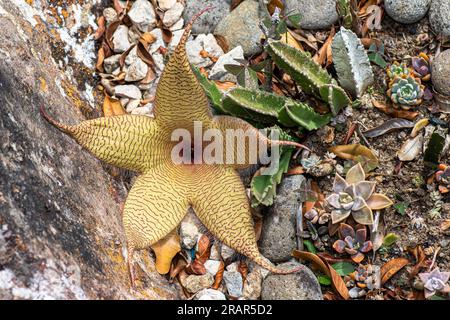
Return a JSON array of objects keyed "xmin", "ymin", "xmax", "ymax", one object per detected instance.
[{"xmin": 0, "ymin": 0, "xmax": 183, "ymax": 300}]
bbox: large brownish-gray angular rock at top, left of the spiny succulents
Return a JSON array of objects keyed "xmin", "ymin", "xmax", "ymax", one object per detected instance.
[{"xmin": 214, "ymin": 0, "xmax": 263, "ymax": 56}]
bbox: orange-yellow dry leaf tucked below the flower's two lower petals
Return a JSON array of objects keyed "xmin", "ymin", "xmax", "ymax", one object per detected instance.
[{"xmin": 151, "ymin": 232, "xmax": 181, "ymax": 274}]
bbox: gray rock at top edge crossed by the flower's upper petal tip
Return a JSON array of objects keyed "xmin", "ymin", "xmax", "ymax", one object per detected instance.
[{"xmin": 183, "ymin": 0, "xmax": 231, "ymax": 34}]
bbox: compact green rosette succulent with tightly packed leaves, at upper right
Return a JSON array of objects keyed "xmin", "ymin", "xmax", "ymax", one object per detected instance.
[{"xmin": 387, "ymin": 76, "xmax": 425, "ymax": 109}]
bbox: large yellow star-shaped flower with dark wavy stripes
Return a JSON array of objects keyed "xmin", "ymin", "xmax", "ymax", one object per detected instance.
[{"xmin": 43, "ymin": 9, "xmax": 299, "ymax": 282}]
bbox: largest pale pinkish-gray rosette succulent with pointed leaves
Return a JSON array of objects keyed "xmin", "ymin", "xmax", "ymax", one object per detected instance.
[{"xmin": 326, "ymin": 163, "xmax": 393, "ymax": 225}]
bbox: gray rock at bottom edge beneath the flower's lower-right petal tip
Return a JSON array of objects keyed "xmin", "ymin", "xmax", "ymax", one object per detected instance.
[{"xmin": 261, "ymin": 262, "xmax": 323, "ymax": 300}]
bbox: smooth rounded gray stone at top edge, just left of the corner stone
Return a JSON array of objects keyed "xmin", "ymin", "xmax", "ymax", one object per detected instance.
[{"xmin": 384, "ymin": 0, "xmax": 431, "ymax": 24}]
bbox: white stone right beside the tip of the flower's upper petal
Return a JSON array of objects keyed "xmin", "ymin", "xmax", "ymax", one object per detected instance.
[{"xmin": 186, "ymin": 33, "xmax": 224, "ymax": 68}]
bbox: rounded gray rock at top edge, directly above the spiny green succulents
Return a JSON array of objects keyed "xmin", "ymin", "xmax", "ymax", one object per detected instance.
[{"xmin": 286, "ymin": 0, "xmax": 339, "ymax": 29}]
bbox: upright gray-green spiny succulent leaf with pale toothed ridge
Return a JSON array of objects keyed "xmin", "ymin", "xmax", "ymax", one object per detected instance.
[{"xmin": 331, "ymin": 27, "xmax": 374, "ymax": 97}]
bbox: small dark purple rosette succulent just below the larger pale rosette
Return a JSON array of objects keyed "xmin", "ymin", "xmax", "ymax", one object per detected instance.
[{"xmin": 333, "ymin": 223, "xmax": 373, "ymax": 263}]
